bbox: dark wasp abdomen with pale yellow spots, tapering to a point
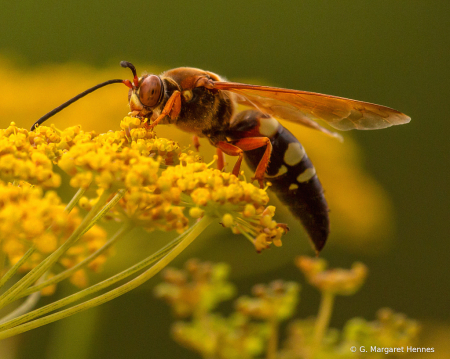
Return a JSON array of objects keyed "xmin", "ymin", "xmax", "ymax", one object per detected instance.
[{"xmin": 227, "ymin": 110, "xmax": 330, "ymax": 252}]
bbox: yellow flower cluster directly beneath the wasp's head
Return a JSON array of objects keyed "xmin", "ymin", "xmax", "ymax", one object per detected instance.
[{"xmin": 58, "ymin": 117, "xmax": 179, "ymax": 189}]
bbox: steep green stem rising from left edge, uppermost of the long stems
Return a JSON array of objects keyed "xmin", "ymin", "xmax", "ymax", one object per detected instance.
[{"xmin": 0, "ymin": 191, "xmax": 112, "ymax": 308}]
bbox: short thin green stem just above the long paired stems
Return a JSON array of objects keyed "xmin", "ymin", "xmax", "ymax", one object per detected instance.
[{"xmin": 17, "ymin": 222, "xmax": 133, "ymax": 298}]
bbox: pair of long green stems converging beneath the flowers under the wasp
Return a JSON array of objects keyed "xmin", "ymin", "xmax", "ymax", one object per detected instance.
[{"xmin": 0, "ymin": 216, "xmax": 213, "ymax": 340}]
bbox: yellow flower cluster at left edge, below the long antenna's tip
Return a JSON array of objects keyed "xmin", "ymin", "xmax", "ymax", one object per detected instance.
[{"xmin": 0, "ymin": 122, "xmax": 61, "ymax": 188}]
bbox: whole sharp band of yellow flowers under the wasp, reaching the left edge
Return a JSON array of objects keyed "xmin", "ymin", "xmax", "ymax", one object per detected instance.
[{"xmin": 0, "ymin": 117, "xmax": 286, "ymax": 265}]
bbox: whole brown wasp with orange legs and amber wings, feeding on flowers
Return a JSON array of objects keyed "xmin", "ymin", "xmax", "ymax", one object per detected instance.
[{"xmin": 32, "ymin": 61, "xmax": 410, "ymax": 253}]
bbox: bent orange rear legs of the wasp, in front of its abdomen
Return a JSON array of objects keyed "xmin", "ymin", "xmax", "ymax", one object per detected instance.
[{"xmin": 217, "ymin": 137, "xmax": 272, "ymax": 188}]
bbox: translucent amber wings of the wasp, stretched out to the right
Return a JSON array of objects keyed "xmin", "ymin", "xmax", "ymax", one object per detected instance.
[{"xmin": 214, "ymin": 81, "xmax": 411, "ymax": 137}]
